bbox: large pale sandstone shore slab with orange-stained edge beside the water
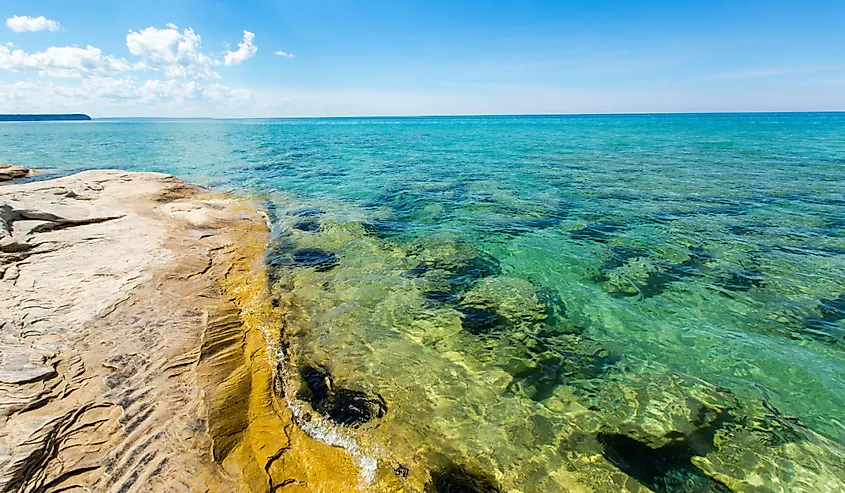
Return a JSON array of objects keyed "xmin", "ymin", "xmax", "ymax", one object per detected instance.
[{"xmin": 0, "ymin": 171, "xmax": 358, "ymax": 492}]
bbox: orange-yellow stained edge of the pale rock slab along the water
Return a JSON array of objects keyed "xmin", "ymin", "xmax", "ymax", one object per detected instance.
[{"xmin": 193, "ymin": 197, "xmax": 380, "ymax": 493}]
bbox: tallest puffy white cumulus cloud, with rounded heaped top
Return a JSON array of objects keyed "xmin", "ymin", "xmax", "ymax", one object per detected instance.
[{"xmin": 126, "ymin": 24, "xmax": 220, "ymax": 79}]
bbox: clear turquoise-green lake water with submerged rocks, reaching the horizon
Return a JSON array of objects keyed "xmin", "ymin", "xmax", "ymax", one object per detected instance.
[{"xmin": 0, "ymin": 114, "xmax": 845, "ymax": 492}]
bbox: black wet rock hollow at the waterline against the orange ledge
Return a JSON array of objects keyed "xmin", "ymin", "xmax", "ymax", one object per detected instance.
[{"xmin": 297, "ymin": 366, "xmax": 387, "ymax": 428}]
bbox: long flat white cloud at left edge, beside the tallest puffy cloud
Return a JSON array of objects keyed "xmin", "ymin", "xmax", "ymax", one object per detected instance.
[{"xmin": 0, "ymin": 46, "xmax": 130, "ymax": 78}]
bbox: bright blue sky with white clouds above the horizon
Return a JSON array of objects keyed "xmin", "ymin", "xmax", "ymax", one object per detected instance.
[{"xmin": 0, "ymin": 0, "xmax": 845, "ymax": 117}]
